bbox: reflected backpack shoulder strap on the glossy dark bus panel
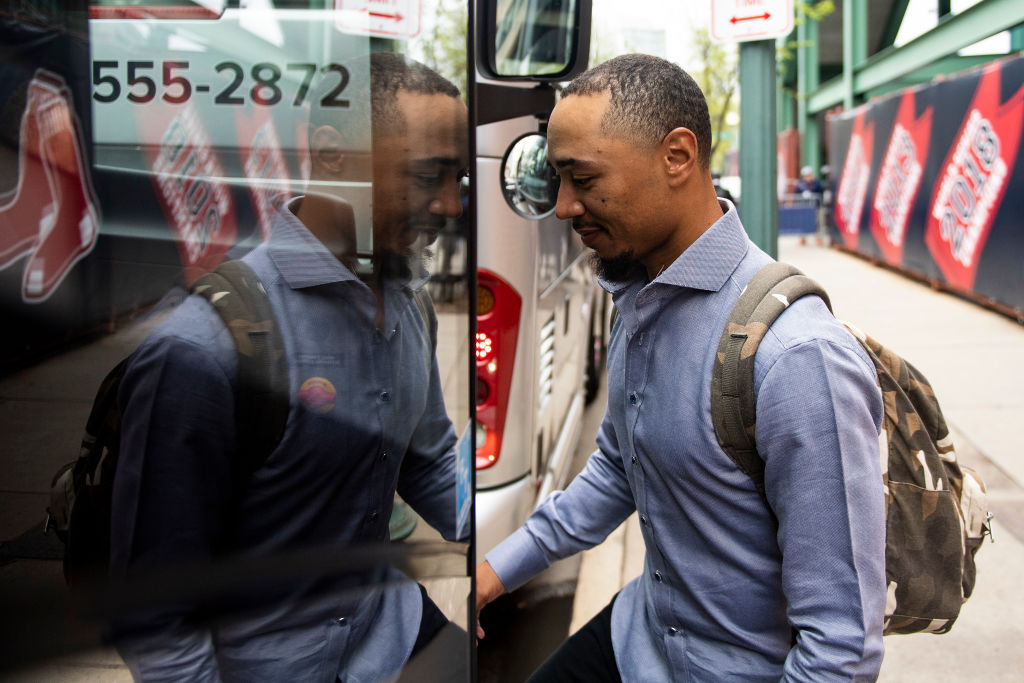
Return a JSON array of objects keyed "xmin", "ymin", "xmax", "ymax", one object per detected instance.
[{"xmin": 191, "ymin": 260, "xmax": 289, "ymax": 472}]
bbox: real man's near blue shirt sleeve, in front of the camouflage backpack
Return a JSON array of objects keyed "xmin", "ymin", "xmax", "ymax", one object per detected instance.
[{"xmin": 757, "ymin": 337, "xmax": 886, "ymax": 681}]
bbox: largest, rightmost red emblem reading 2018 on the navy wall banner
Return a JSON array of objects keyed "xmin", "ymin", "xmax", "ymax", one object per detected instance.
[{"xmin": 925, "ymin": 63, "xmax": 1024, "ymax": 290}]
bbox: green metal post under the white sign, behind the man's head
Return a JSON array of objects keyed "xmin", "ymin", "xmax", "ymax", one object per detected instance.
[{"xmin": 739, "ymin": 40, "xmax": 778, "ymax": 258}]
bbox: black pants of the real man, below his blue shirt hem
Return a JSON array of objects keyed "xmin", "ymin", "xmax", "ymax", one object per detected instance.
[{"xmin": 527, "ymin": 595, "xmax": 623, "ymax": 683}]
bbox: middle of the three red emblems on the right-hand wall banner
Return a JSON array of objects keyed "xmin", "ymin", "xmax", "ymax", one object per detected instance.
[{"xmin": 871, "ymin": 90, "xmax": 933, "ymax": 266}]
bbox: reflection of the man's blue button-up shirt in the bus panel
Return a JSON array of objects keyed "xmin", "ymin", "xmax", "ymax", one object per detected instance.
[{"xmin": 112, "ymin": 201, "xmax": 456, "ymax": 682}]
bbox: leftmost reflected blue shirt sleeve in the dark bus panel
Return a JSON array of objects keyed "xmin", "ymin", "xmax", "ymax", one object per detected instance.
[{"xmin": 111, "ymin": 309, "xmax": 236, "ymax": 680}]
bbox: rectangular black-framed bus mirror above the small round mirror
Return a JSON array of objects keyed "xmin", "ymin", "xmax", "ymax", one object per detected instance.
[{"xmin": 476, "ymin": 0, "xmax": 592, "ymax": 82}]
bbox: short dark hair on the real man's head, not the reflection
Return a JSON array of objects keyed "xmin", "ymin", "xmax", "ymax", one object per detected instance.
[{"xmin": 562, "ymin": 54, "xmax": 711, "ymax": 168}]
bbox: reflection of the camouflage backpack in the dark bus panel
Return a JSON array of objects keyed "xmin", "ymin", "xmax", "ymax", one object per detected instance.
[{"xmin": 46, "ymin": 261, "xmax": 288, "ymax": 586}]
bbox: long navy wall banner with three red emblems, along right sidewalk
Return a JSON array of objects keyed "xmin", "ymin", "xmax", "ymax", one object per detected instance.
[{"xmin": 828, "ymin": 56, "xmax": 1024, "ymax": 311}]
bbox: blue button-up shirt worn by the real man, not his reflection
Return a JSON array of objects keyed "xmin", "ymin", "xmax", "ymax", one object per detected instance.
[{"xmin": 487, "ymin": 203, "xmax": 886, "ymax": 683}]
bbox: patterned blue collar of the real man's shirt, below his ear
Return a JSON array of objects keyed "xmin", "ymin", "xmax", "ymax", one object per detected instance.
[{"xmin": 598, "ymin": 199, "xmax": 750, "ymax": 294}]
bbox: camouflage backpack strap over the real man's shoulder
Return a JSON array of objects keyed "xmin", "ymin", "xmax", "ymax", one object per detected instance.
[{"xmin": 711, "ymin": 262, "xmax": 831, "ymax": 498}]
